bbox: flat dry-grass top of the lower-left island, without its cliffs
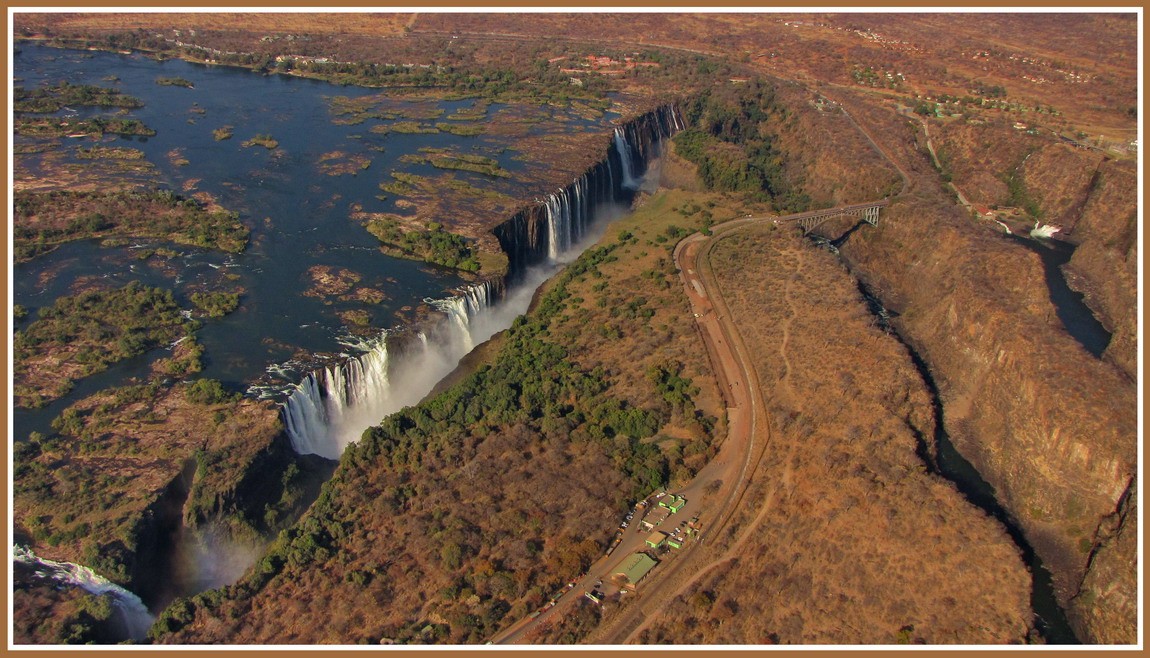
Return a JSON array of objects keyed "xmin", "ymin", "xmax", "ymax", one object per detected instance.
[{"xmin": 14, "ymin": 387, "xmax": 281, "ymax": 577}]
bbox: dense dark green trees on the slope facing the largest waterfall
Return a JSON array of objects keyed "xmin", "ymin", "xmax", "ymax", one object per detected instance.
[{"xmin": 345, "ymin": 245, "xmax": 669, "ymax": 497}]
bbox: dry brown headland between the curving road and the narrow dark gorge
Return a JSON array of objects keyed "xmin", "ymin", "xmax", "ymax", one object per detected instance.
[{"xmin": 631, "ymin": 224, "xmax": 1029, "ymax": 644}]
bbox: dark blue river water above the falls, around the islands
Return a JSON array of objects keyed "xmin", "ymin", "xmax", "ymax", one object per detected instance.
[{"xmin": 13, "ymin": 39, "xmax": 607, "ymax": 437}]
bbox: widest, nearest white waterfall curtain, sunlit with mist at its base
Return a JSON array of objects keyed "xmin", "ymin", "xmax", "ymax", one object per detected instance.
[{"xmin": 282, "ymin": 277, "xmax": 499, "ymax": 459}]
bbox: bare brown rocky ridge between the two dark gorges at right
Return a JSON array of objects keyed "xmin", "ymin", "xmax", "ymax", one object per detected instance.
[{"xmin": 844, "ymin": 193, "xmax": 1137, "ymax": 641}]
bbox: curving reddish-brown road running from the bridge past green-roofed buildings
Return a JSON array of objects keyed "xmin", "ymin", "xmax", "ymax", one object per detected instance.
[{"xmin": 490, "ymin": 206, "xmax": 883, "ymax": 644}]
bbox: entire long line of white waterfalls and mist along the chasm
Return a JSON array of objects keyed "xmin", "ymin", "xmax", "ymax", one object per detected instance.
[{"xmin": 283, "ymin": 106, "xmax": 682, "ymax": 459}]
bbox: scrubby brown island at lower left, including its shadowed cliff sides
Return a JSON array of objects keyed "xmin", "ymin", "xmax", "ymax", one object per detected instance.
[{"xmin": 13, "ymin": 380, "xmax": 324, "ymax": 611}]
